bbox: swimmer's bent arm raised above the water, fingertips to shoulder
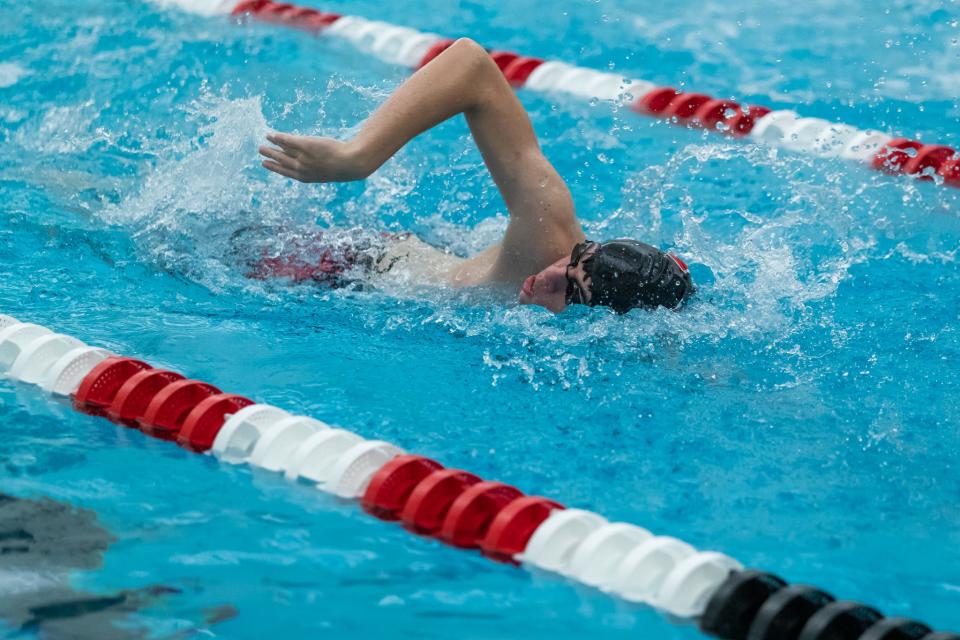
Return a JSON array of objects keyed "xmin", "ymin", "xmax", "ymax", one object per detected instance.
[{"xmin": 260, "ymin": 39, "xmax": 583, "ymax": 264}]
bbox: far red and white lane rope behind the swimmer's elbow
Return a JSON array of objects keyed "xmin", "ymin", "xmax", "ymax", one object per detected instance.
[{"xmin": 159, "ymin": 0, "xmax": 960, "ymax": 187}]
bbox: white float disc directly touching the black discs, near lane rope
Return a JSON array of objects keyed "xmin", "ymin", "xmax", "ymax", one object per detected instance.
[{"xmin": 653, "ymin": 551, "xmax": 743, "ymax": 618}]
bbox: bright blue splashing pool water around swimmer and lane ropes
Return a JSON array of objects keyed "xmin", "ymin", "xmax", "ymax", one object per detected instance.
[{"xmin": 0, "ymin": 0, "xmax": 960, "ymax": 638}]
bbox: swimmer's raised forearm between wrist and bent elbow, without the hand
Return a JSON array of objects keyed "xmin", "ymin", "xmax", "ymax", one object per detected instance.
[{"xmin": 348, "ymin": 39, "xmax": 512, "ymax": 175}]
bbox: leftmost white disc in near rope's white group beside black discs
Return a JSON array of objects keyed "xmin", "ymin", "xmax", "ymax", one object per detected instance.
[{"xmin": 517, "ymin": 509, "xmax": 608, "ymax": 573}]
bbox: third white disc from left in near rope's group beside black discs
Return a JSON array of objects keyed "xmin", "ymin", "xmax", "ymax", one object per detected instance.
[{"xmin": 607, "ymin": 536, "xmax": 697, "ymax": 604}]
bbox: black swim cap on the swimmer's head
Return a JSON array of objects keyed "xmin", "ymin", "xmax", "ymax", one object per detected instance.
[{"xmin": 583, "ymin": 239, "xmax": 695, "ymax": 313}]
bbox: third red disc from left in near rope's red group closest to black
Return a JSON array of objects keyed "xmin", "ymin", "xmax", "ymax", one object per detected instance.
[{"xmin": 440, "ymin": 482, "xmax": 523, "ymax": 548}]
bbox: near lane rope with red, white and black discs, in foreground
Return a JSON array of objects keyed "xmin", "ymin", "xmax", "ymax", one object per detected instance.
[{"xmin": 0, "ymin": 314, "xmax": 960, "ymax": 640}]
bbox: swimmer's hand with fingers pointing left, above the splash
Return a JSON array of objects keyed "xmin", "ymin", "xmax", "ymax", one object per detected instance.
[{"xmin": 260, "ymin": 133, "xmax": 372, "ymax": 182}]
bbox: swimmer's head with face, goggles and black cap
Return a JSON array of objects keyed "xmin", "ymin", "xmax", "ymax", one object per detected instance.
[{"xmin": 520, "ymin": 240, "xmax": 695, "ymax": 313}]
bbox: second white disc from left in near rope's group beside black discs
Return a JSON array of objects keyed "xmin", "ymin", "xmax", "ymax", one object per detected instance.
[{"xmin": 565, "ymin": 522, "xmax": 653, "ymax": 587}]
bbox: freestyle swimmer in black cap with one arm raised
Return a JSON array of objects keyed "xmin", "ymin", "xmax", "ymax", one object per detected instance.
[{"xmin": 260, "ymin": 39, "xmax": 694, "ymax": 313}]
